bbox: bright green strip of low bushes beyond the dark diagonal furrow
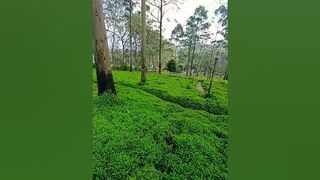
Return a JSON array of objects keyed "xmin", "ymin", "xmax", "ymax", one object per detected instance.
[{"xmin": 92, "ymin": 71, "xmax": 228, "ymax": 115}]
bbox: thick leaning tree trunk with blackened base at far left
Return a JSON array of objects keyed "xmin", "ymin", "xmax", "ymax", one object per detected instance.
[{"xmin": 92, "ymin": 0, "xmax": 116, "ymax": 95}]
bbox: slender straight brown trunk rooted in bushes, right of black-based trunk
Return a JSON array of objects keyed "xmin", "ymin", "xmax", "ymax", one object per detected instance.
[{"xmin": 141, "ymin": 0, "xmax": 147, "ymax": 83}]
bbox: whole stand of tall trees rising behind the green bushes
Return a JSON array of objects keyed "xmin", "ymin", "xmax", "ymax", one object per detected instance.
[{"xmin": 93, "ymin": 0, "xmax": 228, "ymax": 94}]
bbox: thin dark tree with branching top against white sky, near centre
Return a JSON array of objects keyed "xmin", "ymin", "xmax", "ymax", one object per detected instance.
[{"xmin": 148, "ymin": 0, "xmax": 178, "ymax": 74}]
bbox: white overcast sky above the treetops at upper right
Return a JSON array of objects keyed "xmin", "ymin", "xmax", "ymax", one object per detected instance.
[{"xmin": 150, "ymin": 0, "xmax": 227, "ymax": 40}]
